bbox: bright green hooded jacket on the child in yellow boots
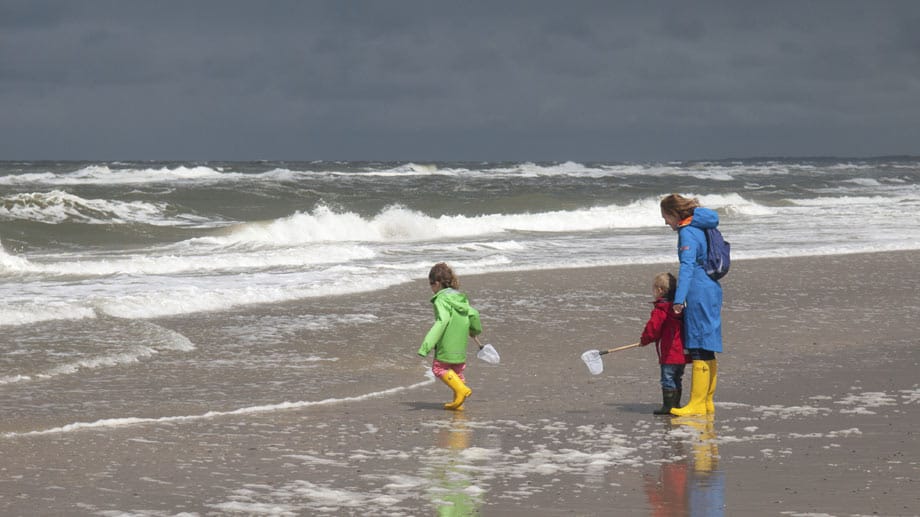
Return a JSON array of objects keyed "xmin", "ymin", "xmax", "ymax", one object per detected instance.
[{"xmin": 418, "ymin": 287, "xmax": 482, "ymax": 364}]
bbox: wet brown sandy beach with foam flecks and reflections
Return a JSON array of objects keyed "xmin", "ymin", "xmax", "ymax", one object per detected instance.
[{"xmin": 0, "ymin": 252, "xmax": 920, "ymax": 516}]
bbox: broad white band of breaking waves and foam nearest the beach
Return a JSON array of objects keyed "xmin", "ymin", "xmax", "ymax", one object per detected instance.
[{"xmin": 0, "ymin": 182, "xmax": 920, "ymax": 325}]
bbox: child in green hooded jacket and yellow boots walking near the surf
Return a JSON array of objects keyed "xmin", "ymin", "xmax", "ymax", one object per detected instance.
[{"xmin": 418, "ymin": 262, "xmax": 482, "ymax": 411}]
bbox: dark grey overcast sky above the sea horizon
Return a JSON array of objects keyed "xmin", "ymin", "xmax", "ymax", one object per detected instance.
[{"xmin": 0, "ymin": 0, "xmax": 920, "ymax": 161}]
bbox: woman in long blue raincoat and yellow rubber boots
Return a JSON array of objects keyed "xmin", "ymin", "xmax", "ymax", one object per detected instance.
[{"xmin": 661, "ymin": 194, "xmax": 722, "ymax": 416}]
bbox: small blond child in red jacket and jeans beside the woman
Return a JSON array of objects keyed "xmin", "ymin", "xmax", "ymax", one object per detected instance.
[{"xmin": 639, "ymin": 273, "xmax": 689, "ymax": 415}]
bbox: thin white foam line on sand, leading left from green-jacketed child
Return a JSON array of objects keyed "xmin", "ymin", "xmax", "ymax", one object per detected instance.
[{"xmin": 3, "ymin": 375, "xmax": 434, "ymax": 438}]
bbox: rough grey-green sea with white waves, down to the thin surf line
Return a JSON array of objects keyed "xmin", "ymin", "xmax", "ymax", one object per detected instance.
[{"xmin": 0, "ymin": 158, "xmax": 920, "ymax": 434}]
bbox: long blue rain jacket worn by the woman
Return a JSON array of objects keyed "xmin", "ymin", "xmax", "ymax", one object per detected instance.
[{"xmin": 674, "ymin": 208, "xmax": 722, "ymax": 352}]
